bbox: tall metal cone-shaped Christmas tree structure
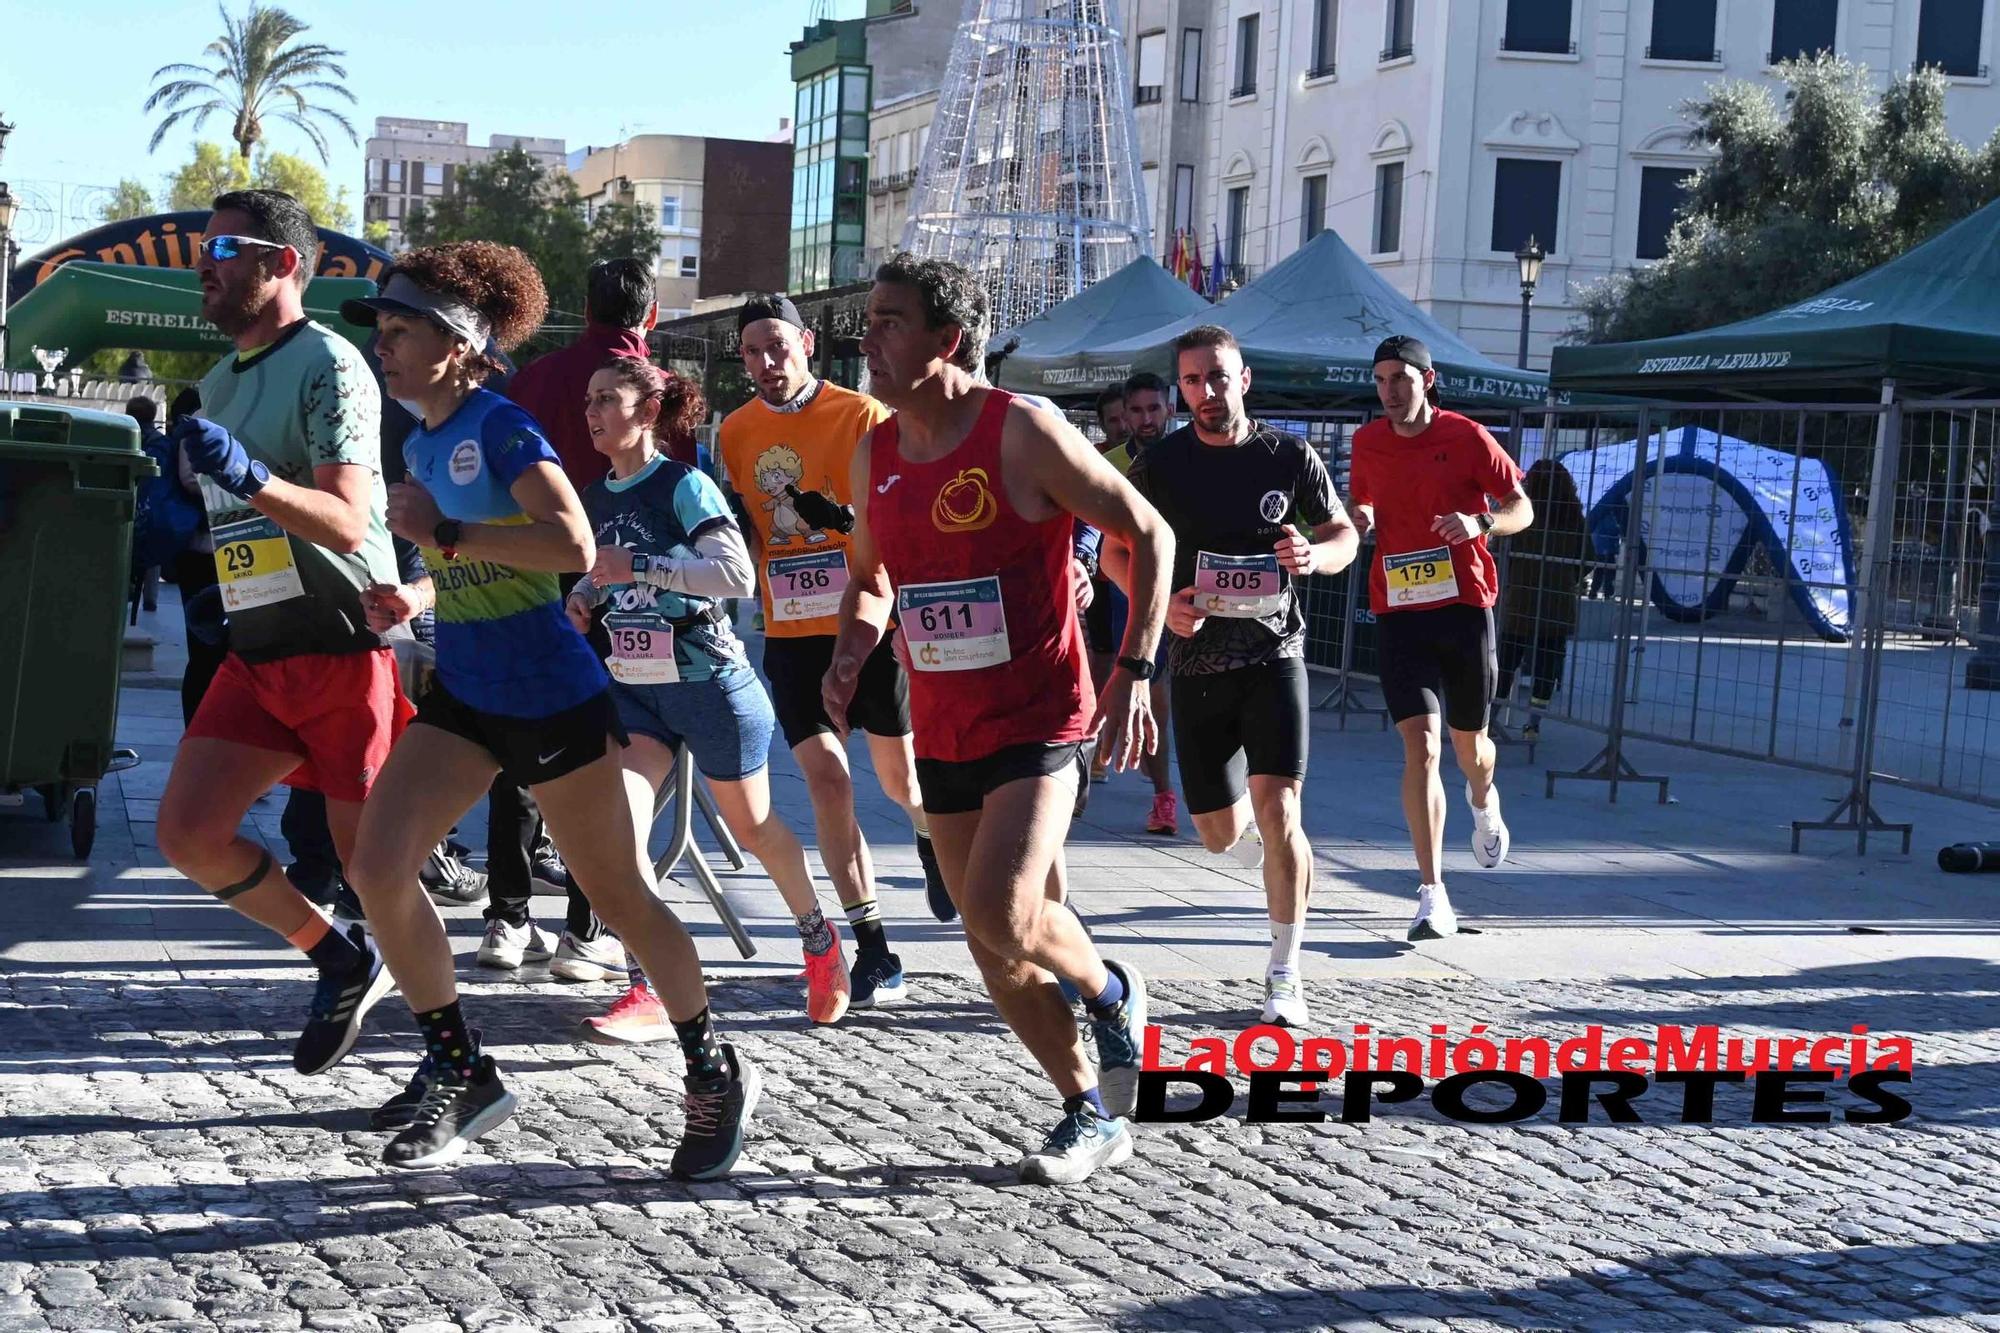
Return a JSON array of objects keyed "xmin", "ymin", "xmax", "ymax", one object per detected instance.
[{"xmin": 902, "ymin": 0, "xmax": 1152, "ymax": 330}]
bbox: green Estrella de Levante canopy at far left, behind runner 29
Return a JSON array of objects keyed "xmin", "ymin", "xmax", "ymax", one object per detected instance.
[{"xmin": 6, "ymin": 260, "xmax": 374, "ymax": 370}]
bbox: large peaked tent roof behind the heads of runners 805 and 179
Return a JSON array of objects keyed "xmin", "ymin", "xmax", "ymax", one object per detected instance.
[{"xmin": 1002, "ymin": 230, "xmax": 1548, "ymax": 412}]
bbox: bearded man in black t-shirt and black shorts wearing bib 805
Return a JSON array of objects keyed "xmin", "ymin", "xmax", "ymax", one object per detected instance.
[{"xmin": 1114, "ymin": 324, "xmax": 1360, "ymax": 1027}]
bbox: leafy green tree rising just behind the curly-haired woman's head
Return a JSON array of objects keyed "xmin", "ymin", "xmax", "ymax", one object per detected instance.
[{"xmin": 402, "ymin": 146, "xmax": 592, "ymax": 322}]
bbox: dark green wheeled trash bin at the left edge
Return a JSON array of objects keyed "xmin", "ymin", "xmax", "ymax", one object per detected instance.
[{"xmin": 0, "ymin": 402, "xmax": 158, "ymax": 857}]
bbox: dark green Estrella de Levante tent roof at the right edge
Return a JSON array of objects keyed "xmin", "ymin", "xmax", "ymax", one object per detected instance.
[{"xmin": 1552, "ymin": 202, "xmax": 2000, "ymax": 402}]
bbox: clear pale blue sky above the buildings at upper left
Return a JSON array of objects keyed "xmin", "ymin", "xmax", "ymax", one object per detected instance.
[{"xmin": 0, "ymin": 0, "xmax": 820, "ymax": 248}]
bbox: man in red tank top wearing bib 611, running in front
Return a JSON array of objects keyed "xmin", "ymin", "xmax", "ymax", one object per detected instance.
[{"xmin": 826, "ymin": 254, "xmax": 1174, "ymax": 1185}]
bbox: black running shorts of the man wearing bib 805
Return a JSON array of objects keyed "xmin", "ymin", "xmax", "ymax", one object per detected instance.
[{"xmin": 1170, "ymin": 656, "xmax": 1306, "ymax": 815}]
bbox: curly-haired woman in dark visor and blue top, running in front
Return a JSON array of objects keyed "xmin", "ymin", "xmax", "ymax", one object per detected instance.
[{"xmin": 342, "ymin": 240, "xmax": 758, "ymax": 1179}]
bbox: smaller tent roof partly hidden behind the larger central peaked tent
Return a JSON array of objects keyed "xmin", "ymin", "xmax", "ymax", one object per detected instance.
[{"xmin": 992, "ymin": 256, "xmax": 1212, "ymax": 398}]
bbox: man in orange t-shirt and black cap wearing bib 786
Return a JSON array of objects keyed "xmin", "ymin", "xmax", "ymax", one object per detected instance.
[{"xmin": 720, "ymin": 294, "xmax": 956, "ymax": 996}]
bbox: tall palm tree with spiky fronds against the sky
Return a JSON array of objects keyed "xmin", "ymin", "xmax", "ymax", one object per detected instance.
[{"xmin": 146, "ymin": 0, "xmax": 362, "ymax": 166}]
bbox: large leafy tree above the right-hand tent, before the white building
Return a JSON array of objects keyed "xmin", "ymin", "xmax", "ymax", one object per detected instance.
[{"xmin": 1570, "ymin": 54, "xmax": 2000, "ymax": 342}]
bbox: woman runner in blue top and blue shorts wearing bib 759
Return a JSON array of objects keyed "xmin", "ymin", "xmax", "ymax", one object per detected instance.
[{"xmin": 568, "ymin": 356, "xmax": 868, "ymax": 1041}]
